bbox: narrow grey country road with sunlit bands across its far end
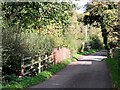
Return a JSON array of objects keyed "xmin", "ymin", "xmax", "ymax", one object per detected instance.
[{"xmin": 28, "ymin": 50, "xmax": 112, "ymax": 89}]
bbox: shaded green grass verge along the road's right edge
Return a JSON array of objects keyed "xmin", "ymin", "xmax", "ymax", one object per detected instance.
[{"xmin": 103, "ymin": 58, "xmax": 120, "ymax": 90}]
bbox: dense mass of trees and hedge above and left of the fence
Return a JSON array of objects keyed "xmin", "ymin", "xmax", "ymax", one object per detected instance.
[{"xmin": 2, "ymin": 2, "xmax": 72, "ymax": 75}]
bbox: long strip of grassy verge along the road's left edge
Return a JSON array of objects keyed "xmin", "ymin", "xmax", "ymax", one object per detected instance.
[{"xmin": 2, "ymin": 49, "xmax": 98, "ymax": 90}]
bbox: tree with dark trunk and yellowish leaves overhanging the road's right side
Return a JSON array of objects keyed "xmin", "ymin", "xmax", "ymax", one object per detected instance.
[{"xmin": 79, "ymin": 2, "xmax": 119, "ymax": 56}]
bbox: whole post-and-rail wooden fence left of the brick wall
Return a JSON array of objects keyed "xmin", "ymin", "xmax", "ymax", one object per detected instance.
[{"xmin": 21, "ymin": 54, "xmax": 55, "ymax": 76}]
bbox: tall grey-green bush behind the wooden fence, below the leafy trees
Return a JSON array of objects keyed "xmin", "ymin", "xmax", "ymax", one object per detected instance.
[{"xmin": 2, "ymin": 27, "xmax": 55, "ymax": 75}]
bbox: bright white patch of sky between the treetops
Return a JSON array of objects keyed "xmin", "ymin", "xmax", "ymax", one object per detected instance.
[{"xmin": 73, "ymin": 0, "xmax": 90, "ymax": 14}]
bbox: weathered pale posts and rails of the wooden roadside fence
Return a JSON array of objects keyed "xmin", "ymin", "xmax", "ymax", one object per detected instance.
[{"xmin": 21, "ymin": 52, "xmax": 56, "ymax": 76}]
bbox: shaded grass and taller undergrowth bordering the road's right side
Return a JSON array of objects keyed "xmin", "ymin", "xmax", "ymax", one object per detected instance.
[{"xmin": 104, "ymin": 48, "xmax": 120, "ymax": 90}]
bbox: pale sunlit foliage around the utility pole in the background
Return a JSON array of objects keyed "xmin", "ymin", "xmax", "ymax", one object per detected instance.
[{"xmin": 66, "ymin": 11, "xmax": 102, "ymax": 55}]
